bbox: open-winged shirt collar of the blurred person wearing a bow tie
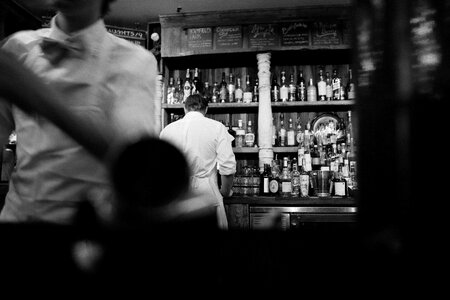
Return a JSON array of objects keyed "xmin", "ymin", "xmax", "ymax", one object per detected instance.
[{"xmin": 49, "ymin": 16, "xmax": 107, "ymax": 55}]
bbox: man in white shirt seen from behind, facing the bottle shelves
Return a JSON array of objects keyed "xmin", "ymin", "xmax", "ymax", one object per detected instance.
[{"xmin": 160, "ymin": 94, "xmax": 236, "ymax": 229}]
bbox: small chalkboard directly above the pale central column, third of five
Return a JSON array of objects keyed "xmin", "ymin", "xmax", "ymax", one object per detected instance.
[{"xmin": 248, "ymin": 24, "xmax": 280, "ymax": 48}]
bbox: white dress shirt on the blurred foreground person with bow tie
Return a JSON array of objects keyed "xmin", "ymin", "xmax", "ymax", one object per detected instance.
[{"xmin": 0, "ymin": 18, "xmax": 161, "ymax": 223}]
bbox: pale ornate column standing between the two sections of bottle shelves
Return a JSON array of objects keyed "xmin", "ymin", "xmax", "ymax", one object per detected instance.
[{"xmin": 256, "ymin": 53, "xmax": 273, "ymax": 171}]
